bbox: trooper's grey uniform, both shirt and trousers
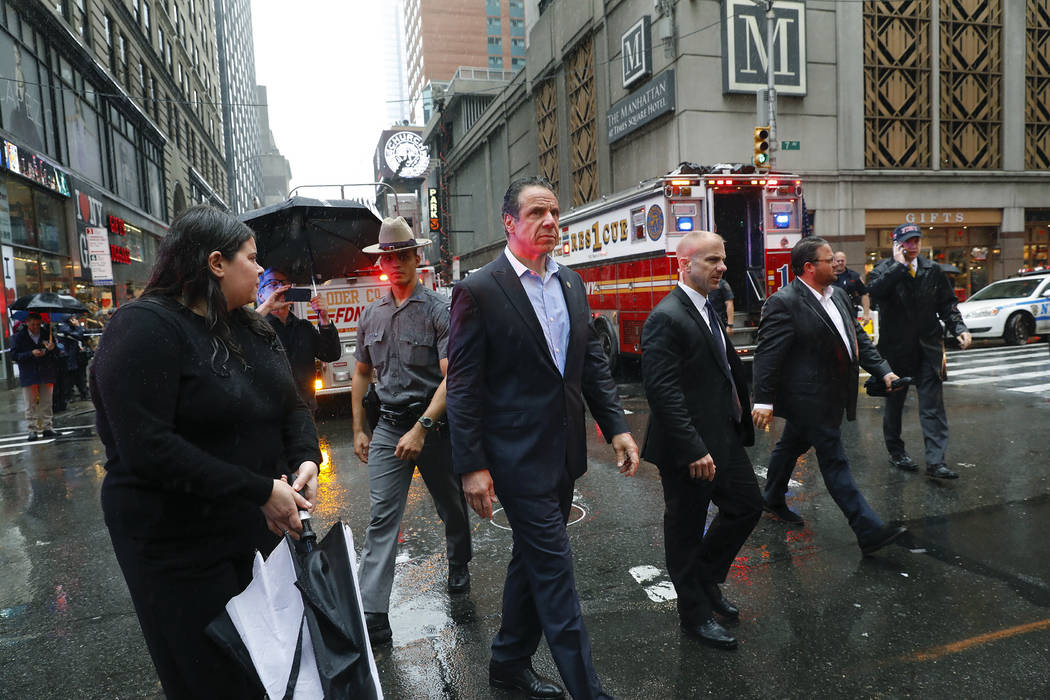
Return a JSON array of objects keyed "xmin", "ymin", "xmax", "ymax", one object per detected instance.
[{"xmin": 354, "ymin": 283, "xmax": 470, "ymax": 613}]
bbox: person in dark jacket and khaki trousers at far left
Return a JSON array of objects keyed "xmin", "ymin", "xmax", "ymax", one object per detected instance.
[{"xmin": 11, "ymin": 312, "xmax": 59, "ymax": 440}]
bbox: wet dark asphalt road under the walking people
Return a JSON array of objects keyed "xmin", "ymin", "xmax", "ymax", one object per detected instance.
[{"xmin": 0, "ymin": 352, "xmax": 1050, "ymax": 699}]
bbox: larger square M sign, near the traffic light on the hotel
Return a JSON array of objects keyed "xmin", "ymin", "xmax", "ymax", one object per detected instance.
[{"xmin": 722, "ymin": 0, "xmax": 806, "ymax": 96}]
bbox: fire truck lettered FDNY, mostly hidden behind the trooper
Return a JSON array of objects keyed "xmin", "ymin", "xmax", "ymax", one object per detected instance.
[{"xmin": 292, "ymin": 266, "xmax": 448, "ymax": 402}]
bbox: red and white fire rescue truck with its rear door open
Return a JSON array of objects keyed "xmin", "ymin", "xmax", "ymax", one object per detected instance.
[{"xmin": 554, "ymin": 163, "xmax": 809, "ymax": 368}]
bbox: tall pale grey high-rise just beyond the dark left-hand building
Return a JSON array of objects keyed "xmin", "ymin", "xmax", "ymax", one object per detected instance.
[{"xmin": 215, "ymin": 0, "xmax": 266, "ymax": 212}]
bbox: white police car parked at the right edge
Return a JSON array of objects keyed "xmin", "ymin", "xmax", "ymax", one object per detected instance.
[{"xmin": 959, "ymin": 268, "xmax": 1050, "ymax": 345}]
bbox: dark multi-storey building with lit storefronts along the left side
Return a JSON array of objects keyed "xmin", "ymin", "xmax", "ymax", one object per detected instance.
[{"xmin": 0, "ymin": 0, "xmax": 227, "ymax": 379}]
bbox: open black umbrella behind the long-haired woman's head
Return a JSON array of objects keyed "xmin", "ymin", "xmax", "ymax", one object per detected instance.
[{"xmin": 239, "ymin": 197, "xmax": 380, "ymax": 284}]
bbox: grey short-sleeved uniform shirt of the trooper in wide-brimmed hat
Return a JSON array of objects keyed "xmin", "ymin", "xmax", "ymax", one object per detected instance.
[{"xmin": 354, "ymin": 283, "xmax": 448, "ymax": 408}]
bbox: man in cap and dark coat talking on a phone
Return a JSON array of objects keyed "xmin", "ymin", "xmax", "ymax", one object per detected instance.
[{"xmin": 868, "ymin": 224, "xmax": 971, "ymax": 479}]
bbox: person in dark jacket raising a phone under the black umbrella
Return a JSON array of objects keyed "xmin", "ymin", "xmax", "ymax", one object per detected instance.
[{"xmin": 255, "ymin": 268, "xmax": 342, "ymax": 410}]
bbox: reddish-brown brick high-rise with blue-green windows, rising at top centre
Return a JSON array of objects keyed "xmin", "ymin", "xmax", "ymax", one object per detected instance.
[{"xmin": 403, "ymin": 0, "xmax": 526, "ymax": 124}]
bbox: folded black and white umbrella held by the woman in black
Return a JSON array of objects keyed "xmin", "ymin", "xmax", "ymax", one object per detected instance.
[{"xmin": 207, "ymin": 518, "xmax": 383, "ymax": 700}]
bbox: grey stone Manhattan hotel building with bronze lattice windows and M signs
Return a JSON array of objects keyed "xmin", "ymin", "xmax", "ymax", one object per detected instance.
[{"xmin": 424, "ymin": 0, "xmax": 1050, "ymax": 297}]
